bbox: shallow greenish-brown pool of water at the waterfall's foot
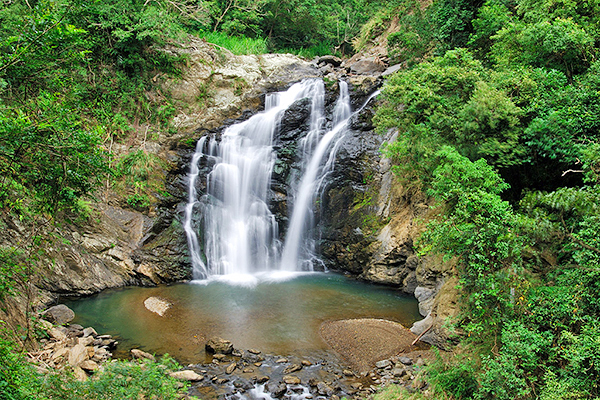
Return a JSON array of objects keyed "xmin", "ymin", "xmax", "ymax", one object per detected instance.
[{"xmin": 65, "ymin": 273, "xmax": 421, "ymax": 363}]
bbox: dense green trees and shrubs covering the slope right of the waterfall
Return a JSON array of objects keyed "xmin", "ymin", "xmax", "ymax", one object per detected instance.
[{"xmin": 375, "ymin": 0, "xmax": 600, "ymax": 400}]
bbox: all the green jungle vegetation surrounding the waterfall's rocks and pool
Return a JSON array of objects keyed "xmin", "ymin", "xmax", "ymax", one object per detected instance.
[{"xmin": 0, "ymin": 0, "xmax": 600, "ymax": 400}]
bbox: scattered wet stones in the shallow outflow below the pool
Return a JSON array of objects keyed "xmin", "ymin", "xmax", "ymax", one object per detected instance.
[{"xmin": 180, "ymin": 349, "xmax": 426, "ymax": 400}]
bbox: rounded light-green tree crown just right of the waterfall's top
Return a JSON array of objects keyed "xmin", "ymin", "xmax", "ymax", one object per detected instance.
[{"xmin": 374, "ymin": 49, "xmax": 525, "ymax": 188}]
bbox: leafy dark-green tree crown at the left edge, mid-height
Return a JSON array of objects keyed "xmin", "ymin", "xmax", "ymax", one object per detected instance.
[{"xmin": 0, "ymin": 92, "xmax": 107, "ymax": 212}]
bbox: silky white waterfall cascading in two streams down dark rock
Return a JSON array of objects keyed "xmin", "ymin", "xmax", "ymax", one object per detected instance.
[{"xmin": 184, "ymin": 79, "xmax": 380, "ymax": 279}]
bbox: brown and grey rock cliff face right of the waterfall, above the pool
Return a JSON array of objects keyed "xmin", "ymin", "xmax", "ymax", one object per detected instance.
[{"xmin": 321, "ymin": 126, "xmax": 458, "ymax": 348}]
